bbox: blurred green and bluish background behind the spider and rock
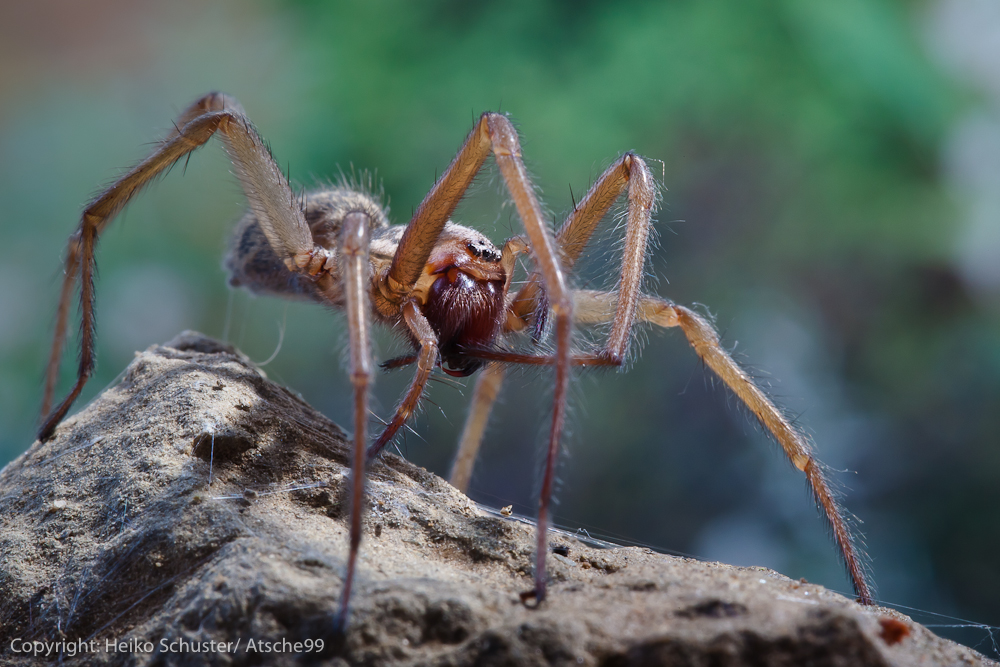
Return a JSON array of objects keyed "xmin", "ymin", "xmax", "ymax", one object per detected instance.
[{"xmin": 0, "ymin": 0, "xmax": 1000, "ymax": 656}]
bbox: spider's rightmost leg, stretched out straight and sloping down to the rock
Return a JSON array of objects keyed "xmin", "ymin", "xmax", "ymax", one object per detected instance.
[{"xmin": 574, "ymin": 290, "xmax": 873, "ymax": 604}]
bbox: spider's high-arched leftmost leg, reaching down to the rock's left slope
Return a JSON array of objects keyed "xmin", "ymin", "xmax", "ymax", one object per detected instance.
[{"xmin": 38, "ymin": 93, "xmax": 328, "ymax": 440}]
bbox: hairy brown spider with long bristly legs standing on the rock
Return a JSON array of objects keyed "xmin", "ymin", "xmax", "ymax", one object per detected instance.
[{"xmin": 39, "ymin": 93, "xmax": 872, "ymax": 629}]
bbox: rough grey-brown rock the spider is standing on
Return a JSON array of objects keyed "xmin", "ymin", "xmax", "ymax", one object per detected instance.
[{"xmin": 0, "ymin": 333, "xmax": 996, "ymax": 667}]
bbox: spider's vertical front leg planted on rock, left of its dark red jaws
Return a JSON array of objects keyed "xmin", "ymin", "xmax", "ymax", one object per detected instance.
[{"xmin": 335, "ymin": 212, "xmax": 372, "ymax": 633}]
